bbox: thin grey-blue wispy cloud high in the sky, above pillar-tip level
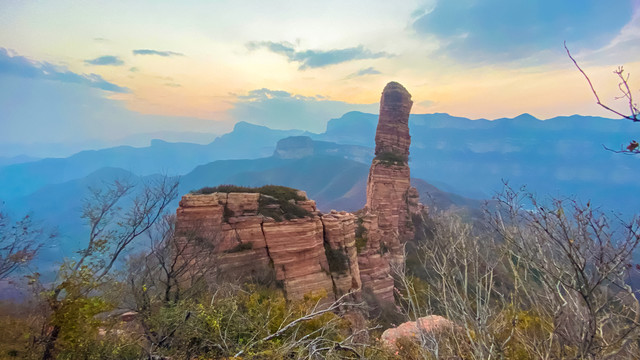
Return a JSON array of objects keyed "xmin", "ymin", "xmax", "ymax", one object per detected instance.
[{"xmin": 246, "ymin": 41, "xmax": 393, "ymax": 70}]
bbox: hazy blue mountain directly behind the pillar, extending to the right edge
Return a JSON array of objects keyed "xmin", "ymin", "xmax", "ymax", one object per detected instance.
[{"xmin": 314, "ymin": 112, "xmax": 640, "ymax": 213}]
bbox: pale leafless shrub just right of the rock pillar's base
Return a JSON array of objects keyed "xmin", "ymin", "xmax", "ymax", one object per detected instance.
[{"xmin": 396, "ymin": 212, "xmax": 513, "ymax": 359}]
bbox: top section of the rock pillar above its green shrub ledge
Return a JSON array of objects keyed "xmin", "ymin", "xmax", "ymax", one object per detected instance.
[{"xmin": 376, "ymin": 81, "xmax": 413, "ymax": 159}]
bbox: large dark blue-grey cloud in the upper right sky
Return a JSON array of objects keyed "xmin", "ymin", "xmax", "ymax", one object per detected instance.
[{"xmin": 412, "ymin": 0, "xmax": 632, "ymax": 62}]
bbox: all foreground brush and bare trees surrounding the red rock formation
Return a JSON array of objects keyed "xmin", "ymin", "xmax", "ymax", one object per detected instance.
[{"xmin": 0, "ymin": 177, "xmax": 640, "ymax": 359}]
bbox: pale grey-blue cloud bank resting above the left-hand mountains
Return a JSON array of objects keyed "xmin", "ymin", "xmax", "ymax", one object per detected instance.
[{"xmin": 0, "ymin": 73, "xmax": 233, "ymax": 153}]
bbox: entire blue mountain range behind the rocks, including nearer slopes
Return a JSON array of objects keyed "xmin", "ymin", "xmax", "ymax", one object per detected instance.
[{"xmin": 0, "ymin": 112, "xmax": 640, "ymax": 268}]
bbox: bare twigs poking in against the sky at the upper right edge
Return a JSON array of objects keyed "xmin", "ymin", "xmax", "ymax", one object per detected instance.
[{"xmin": 564, "ymin": 41, "xmax": 640, "ymax": 154}]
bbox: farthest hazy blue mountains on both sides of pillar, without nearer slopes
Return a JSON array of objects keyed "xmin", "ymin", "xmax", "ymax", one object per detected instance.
[{"xmin": 0, "ymin": 112, "xmax": 640, "ymax": 222}]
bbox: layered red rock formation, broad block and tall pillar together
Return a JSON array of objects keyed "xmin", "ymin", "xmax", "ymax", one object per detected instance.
[{"xmin": 176, "ymin": 82, "xmax": 422, "ymax": 302}]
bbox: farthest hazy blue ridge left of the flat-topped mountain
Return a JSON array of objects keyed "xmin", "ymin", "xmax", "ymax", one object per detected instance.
[{"xmin": 0, "ymin": 122, "xmax": 303, "ymax": 200}]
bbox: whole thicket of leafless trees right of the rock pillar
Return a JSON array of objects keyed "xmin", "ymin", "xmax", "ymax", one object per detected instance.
[{"xmin": 396, "ymin": 185, "xmax": 640, "ymax": 359}]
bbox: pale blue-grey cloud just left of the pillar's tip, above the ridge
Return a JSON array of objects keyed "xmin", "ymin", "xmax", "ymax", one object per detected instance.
[{"xmin": 229, "ymin": 88, "xmax": 378, "ymax": 132}]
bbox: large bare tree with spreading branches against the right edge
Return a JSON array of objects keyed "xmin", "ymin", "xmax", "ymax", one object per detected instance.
[{"xmin": 493, "ymin": 186, "xmax": 640, "ymax": 359}]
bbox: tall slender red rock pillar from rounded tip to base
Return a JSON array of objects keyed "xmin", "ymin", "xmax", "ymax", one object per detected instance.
[{"xmin": 358, "ymin": 82, "xmax": 419, "ymax": 301}]
